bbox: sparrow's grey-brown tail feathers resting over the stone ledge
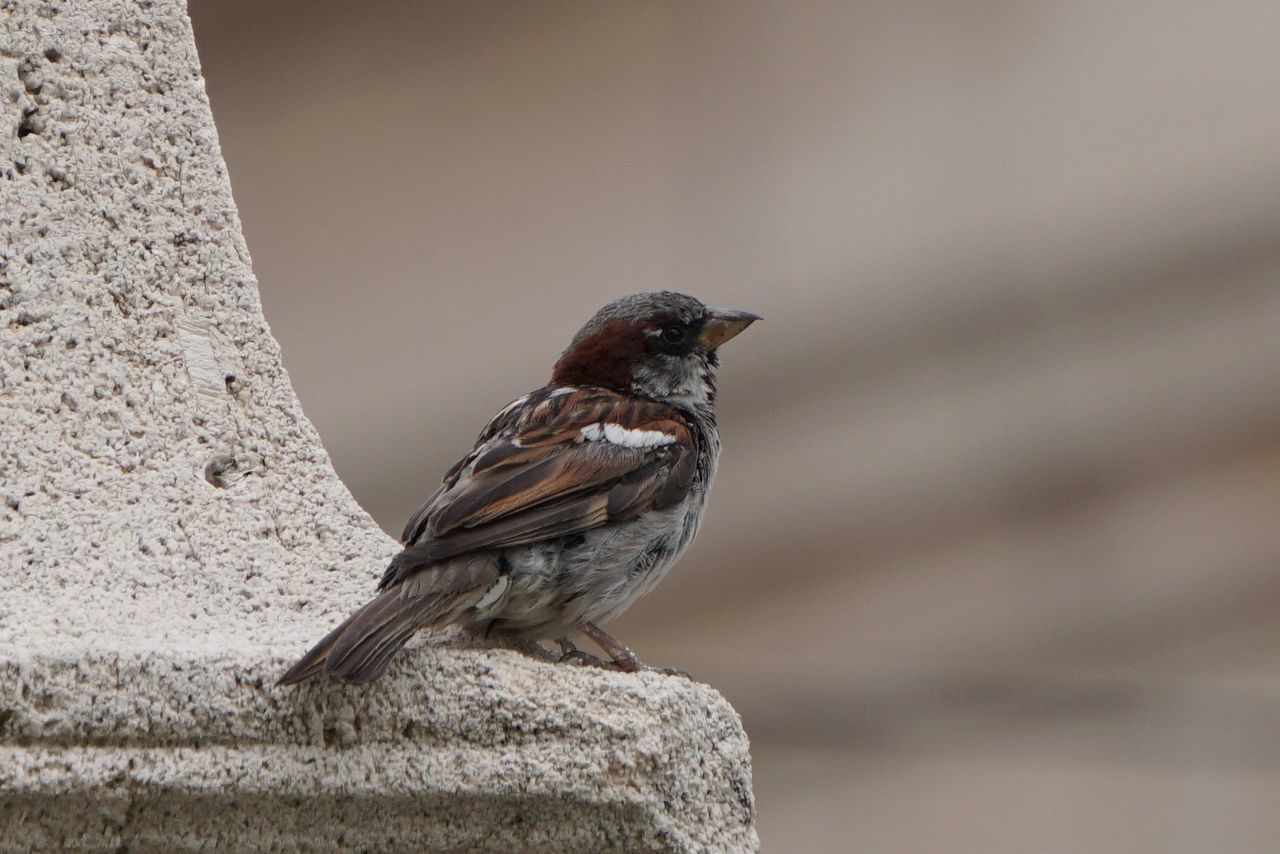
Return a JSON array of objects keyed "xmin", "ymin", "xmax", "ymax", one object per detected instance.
[{"xmin": 276, "ymin": 586, "xmax": 443, "ymax": 685}]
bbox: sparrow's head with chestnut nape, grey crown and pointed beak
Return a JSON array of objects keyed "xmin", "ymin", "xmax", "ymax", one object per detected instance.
[{"xmin": 552, "ymin": 291, "xmax": 759, "ymax": 408}]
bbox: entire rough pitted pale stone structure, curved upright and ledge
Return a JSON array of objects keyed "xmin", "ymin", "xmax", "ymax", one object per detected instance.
[{"xmin": 0, "ymin": 0, "xmax": 756, "ymax": 850}]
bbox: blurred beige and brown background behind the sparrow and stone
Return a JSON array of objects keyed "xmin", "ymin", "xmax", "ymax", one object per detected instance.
[{"xmin": 191, "ymin": 0, "xmax": 1280, "ymax": 851}]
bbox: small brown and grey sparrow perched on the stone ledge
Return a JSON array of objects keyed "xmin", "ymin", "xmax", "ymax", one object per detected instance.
[{"xmin": 278, "ymin": 291, "xmax": 760, "ymax": 685}]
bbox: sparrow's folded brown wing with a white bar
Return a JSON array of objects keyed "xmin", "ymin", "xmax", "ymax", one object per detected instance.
[{"xmin": 380, "ymin": 388, "xmax": 699, "ymax": 588}]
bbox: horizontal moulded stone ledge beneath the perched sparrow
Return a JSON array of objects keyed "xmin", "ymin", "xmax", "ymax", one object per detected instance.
[{"xmin": 0, "ymin": 647, "xmax": 754, "ymax": 850}]
